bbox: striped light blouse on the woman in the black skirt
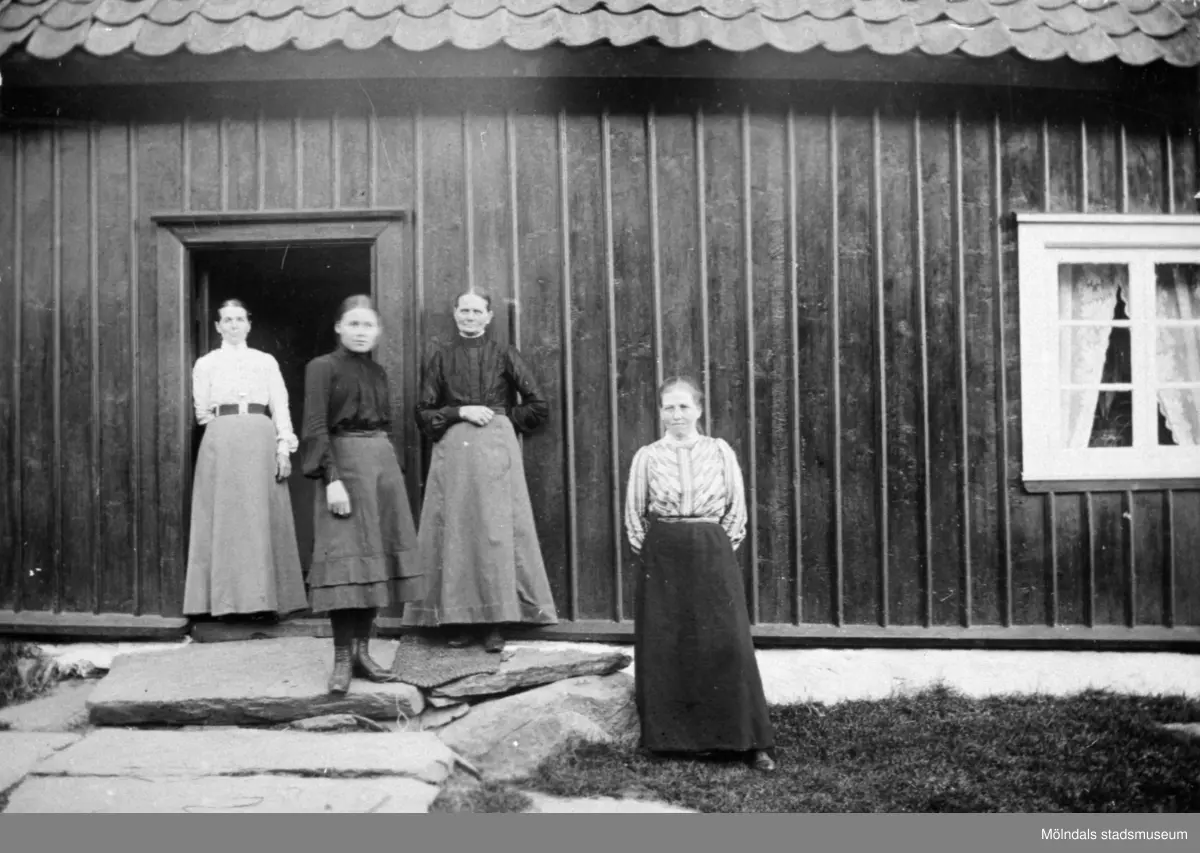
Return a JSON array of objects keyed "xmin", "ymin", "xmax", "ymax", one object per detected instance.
[{"xmin": 625, "ymin": 435, "xmax": 746, "ymax": 553}]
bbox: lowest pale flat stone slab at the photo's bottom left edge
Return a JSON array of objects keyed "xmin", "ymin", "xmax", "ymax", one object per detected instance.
[{"xmin": 5, "ymin": 776, "xmax": 438, "ymax": 815}]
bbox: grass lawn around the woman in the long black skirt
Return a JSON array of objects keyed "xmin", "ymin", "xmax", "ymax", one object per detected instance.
[{"xmin": 522, "ymin": 689, "xmax": 1200, "ymax": 813}]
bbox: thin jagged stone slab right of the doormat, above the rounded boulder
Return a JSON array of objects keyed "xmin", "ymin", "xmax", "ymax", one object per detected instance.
[{"xmin": 431, "ymin": 648, "xmax": 634, "ymax": 699}]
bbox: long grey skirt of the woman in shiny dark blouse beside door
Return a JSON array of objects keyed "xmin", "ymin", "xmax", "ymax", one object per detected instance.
[{"xmin": 403, "ymin": 415, "xmax": 558, "ymax": 626}]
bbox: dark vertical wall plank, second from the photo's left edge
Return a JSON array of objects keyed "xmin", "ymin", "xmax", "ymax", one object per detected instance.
[{"xmin": 17, "ymin": 128, "xmax": 58, "ymax": 611}]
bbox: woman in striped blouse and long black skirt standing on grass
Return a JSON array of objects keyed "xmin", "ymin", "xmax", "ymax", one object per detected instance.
[{"xmin": 625, "ymin": 377, "xmax": 775, "ymax": 771}]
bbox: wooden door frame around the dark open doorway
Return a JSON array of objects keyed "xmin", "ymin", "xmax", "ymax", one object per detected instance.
[{"xmin": 150, "ymin": 208, "xmax": 421, "ymax": 617}]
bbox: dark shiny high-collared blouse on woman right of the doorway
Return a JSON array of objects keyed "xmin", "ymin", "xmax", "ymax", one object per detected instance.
[{"xmin": 416, "ymin": 334, "xmax": 550, "ymax": 441}]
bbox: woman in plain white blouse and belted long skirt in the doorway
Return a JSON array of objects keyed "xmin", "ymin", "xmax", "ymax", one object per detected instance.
[{"xmin": 184, "ymin": 299, "xmax": 307, "ymax": 618}]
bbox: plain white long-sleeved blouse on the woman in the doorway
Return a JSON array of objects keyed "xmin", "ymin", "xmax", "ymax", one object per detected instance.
[{"xmin": 192, "ymin": 342, "xmax": 300, "ymax": 453}]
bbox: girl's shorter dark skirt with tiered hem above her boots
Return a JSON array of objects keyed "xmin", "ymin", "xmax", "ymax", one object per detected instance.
[{"xmin": 308, "ymin": 433, "xmax": 422, "ymax": 612}]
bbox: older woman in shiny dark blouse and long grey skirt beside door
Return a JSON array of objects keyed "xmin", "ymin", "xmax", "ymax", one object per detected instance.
[{"xmin": 403, "ymin": 293, "xmax": 558, "ymax": 651}]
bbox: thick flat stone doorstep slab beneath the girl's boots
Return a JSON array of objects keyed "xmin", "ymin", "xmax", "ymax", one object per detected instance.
[{"xmin": 88, "ymin": 637, "xmax": 425, "ymax": 726}]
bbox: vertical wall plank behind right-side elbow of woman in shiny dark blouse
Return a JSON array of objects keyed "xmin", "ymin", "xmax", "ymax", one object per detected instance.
[{"xmin": 512, "ymin": 113, "xmax": 571, "ymax": 620}]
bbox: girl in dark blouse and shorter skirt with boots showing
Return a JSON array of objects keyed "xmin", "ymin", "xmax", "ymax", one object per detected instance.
[{"xmin": 300, "ymin": 296, "xmax": 420, "ymax": 693}]
